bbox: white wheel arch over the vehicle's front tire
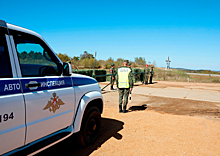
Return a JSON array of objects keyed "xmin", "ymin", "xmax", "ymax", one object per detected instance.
[{"xmin": 73, "ymin": 91, "xmax": 103, "ymax": 132}]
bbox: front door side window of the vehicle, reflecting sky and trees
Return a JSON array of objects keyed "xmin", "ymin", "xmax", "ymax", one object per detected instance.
[{"xmin": 10, "ymin": 31, "xmax": 60, "ymax": 77}]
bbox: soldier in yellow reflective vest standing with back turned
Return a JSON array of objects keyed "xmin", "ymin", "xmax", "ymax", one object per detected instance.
[{"xmin": 116, "ymin": 60, "xmax": 133, "ymax": 113}]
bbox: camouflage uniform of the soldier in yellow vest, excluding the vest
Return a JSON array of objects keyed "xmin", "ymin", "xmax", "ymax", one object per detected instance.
[{"xmin": 116, "ymin": 61, "xmax": 133, "ymax": 113}]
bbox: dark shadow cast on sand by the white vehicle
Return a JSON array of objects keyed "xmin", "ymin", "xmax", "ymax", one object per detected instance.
[{"xmin": 37, "ymin": 118, "xmax": 124, "ymax": 156}]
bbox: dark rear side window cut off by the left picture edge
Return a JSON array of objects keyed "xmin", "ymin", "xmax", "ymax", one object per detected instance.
[{"xmin": 0, "ymin": 27, "xmax": 12, "ymax": 78}]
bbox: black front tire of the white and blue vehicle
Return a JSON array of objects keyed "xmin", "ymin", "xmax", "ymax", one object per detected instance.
[{"xmin": 78, "ymin": 107, "xmax": 101, "ymax": 146}]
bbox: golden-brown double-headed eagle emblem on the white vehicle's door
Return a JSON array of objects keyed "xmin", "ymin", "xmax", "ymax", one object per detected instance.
[{"xmin": 43, "ymin": 92, "xmax": 65, "ymax": 113}]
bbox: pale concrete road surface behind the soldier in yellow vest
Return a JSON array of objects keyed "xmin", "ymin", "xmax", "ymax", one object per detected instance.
[{"xmin": 100, "ymin": 81, "xmax": 220, "ymax": 102}]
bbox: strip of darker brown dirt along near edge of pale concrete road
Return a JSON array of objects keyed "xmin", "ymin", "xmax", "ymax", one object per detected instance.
[{"xmin": 147, "ymin": 96, "xmax": 220, "ymax": 118}]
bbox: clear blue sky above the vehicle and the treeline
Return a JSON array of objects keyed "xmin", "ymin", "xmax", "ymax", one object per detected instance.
[{"xmin": 0, "ymin": 0, "xmax": 220, "ymax": 70}]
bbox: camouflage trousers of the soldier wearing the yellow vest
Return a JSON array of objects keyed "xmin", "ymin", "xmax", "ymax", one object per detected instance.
[{"xmin": 118, "ymin": 88, "xmax": 130, "ymax": 109}]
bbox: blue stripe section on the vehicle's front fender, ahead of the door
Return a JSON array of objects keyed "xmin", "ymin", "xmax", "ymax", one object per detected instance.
[{"xmin": 72, "ymin": 77, "xmax": 97, "ymax": 86}]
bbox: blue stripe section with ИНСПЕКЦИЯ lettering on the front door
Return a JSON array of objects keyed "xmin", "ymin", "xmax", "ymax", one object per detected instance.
[{"xmin": 21, "ymin": 77, "xmax": 72, "ymax": 93}]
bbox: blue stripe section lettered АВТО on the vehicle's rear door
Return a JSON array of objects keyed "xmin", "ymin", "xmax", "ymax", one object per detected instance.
[{"xmin": 0, "ymin": 79, "xmax": 21, "ymax": 96}]
